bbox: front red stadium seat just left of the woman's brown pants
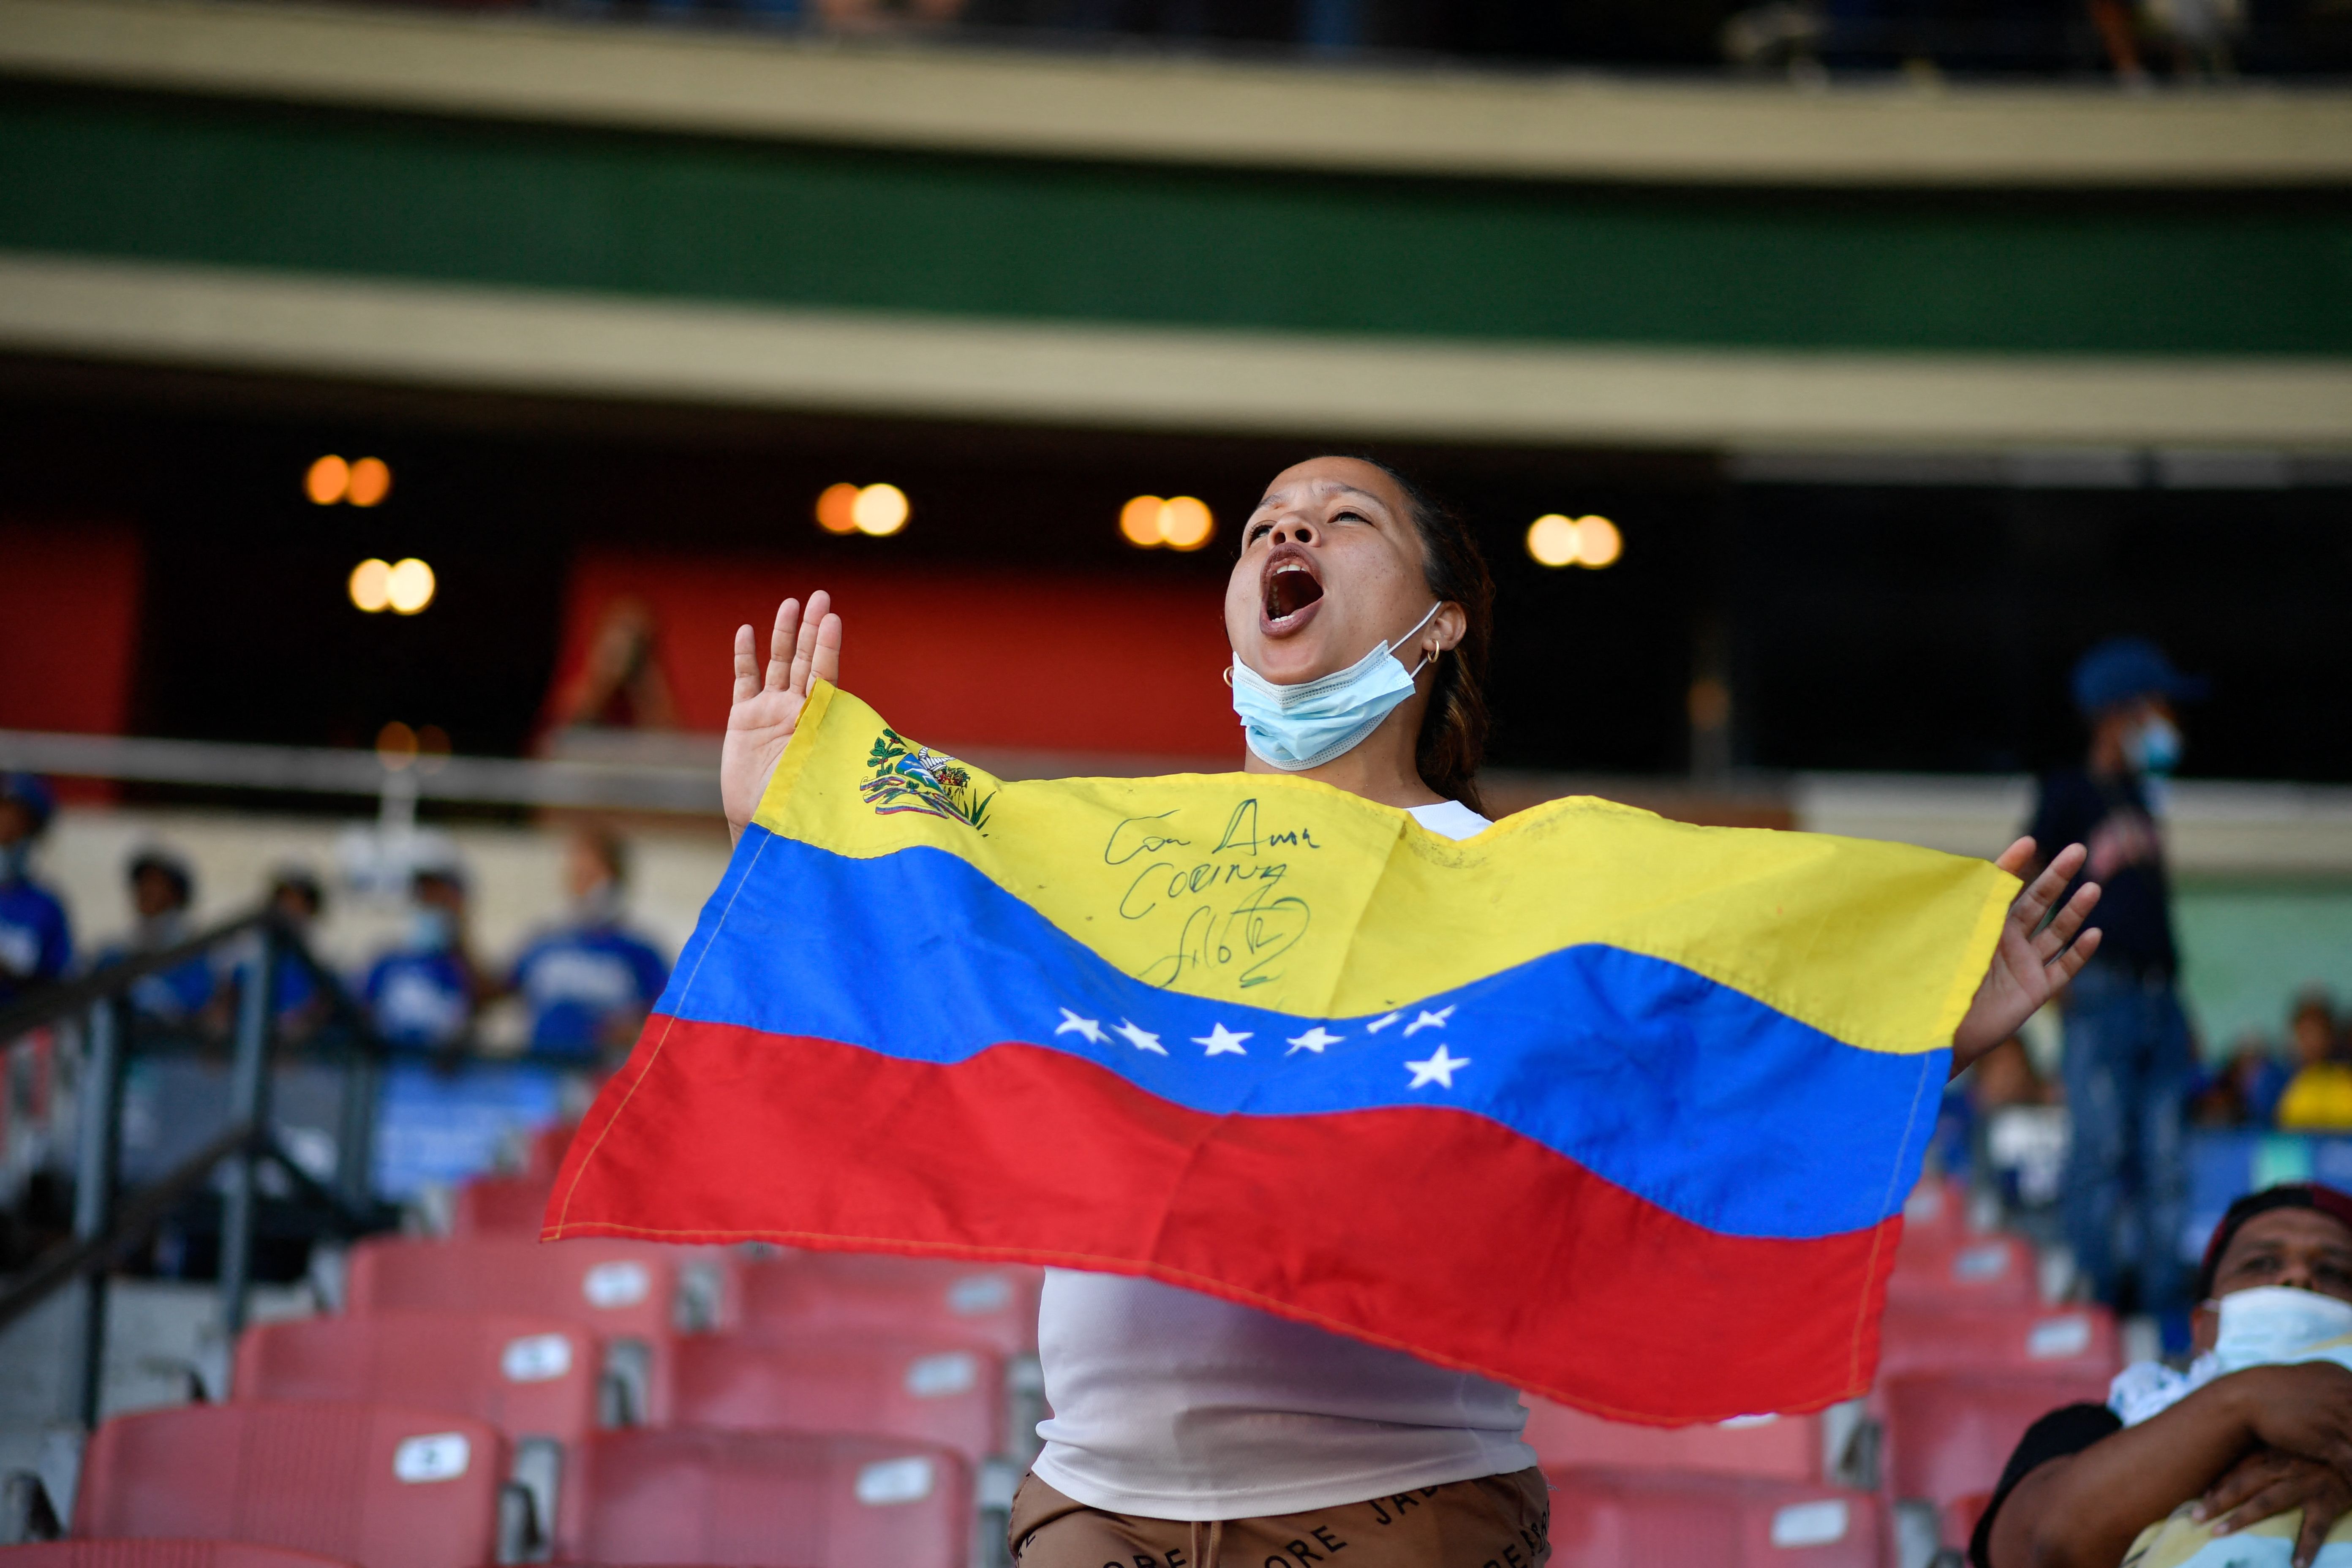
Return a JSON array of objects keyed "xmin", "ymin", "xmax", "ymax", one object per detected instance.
[{"xmin": 569, "ymin": 1429, "xmax": 974, "ymax": 1568}]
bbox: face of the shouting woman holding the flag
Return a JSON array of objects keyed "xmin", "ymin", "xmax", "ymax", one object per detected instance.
[{"xmin": 1225, "ymin": 458, "xmax": 1463, "ymax": 686}]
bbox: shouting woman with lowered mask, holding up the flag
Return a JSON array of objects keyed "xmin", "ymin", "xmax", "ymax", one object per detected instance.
[{"xmin": 720, "ymin": 456, "xmax": 2098, "ymax": 1568}]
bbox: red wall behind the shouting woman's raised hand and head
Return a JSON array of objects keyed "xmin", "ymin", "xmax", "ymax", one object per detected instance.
[{"xmin": 550, "ymin": 550, "xmax": 1242, "ymax": 766}]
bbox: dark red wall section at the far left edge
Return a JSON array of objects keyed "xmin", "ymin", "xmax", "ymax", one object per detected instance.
[{"xmin": 0, "ymin": 524, "xmax": 139, "ymax": 736}]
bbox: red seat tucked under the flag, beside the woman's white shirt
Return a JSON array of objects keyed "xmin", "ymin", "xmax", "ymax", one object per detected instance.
[{"xmin": 743, "ymin": 1253, "xmax": 1044, "ymax": 1356}]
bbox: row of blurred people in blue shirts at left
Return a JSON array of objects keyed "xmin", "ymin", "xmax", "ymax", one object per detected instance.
[{"xmin": 0, "ymin": 773, "xmax": 670, "ymax": 1065}]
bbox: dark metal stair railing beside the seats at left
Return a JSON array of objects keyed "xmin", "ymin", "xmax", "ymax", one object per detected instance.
[{"xmin": 0, "ymin": 910, "xmax": 388, "ymax": 1429}]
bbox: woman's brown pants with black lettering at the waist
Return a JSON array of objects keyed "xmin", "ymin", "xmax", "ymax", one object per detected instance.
[{"xmin": 1007, "ymin": 1469, "xmax": 1552, "ymax": 1568}]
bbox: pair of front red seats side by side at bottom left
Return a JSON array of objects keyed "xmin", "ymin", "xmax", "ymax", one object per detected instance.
[{"xmin": 73, "ymin": 1401, "xmax": 972, "ymax": 1568}]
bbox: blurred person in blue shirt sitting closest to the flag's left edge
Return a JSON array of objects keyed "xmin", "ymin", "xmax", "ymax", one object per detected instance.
[{"xmin": 513, "ymin": 832, "xmax": 670, "ymax": 1060}]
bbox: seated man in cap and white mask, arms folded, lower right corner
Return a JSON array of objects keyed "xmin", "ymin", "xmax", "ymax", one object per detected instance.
[{"xmin": 1968, "ymin": 1182, "xmax": 2352, "ymax": 1568}]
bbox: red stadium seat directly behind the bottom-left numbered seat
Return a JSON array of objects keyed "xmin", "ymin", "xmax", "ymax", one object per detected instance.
[{"xmin": 231, "ymin": 1307, "xmax": 602, "ymax": 1446}]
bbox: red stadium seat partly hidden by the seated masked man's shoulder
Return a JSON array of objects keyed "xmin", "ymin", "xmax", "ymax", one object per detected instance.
[{"xmin": 1877, "ymin": 1371, "xmax": 2107, "ymax": 1547}]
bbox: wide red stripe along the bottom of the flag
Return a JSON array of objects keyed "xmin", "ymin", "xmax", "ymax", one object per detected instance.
[{"xmin": 546, "ymin": 1018, "xmax": 1900, "ymax": 1422}]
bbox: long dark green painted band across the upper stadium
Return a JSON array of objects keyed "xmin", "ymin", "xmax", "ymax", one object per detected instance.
[{"xmin": 0, "ymin": 87, "xmax": 2352, "ymax": 355}]
